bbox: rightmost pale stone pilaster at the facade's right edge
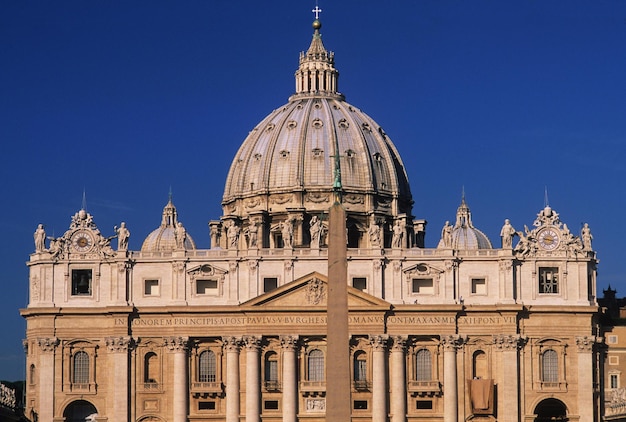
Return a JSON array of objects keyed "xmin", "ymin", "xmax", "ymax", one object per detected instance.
[{"xmin": 576, "ymin": 336, "xmax": 596, "ymax": 421}]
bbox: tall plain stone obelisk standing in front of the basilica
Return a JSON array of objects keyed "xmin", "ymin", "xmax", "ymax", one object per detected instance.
[{"xmin": 326, "ymin": 152, "xmax": 352, "ymax": 422}]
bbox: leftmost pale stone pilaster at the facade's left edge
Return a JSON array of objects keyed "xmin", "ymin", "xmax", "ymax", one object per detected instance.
[{"xmin": 37, "ymin": 337, "xmax": 59, "ymax": 421}]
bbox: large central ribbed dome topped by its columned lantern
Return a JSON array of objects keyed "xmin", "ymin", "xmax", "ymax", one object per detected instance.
[{"xmin": 222, "ymin": 20, "xmax": 413, "ymax": 220}]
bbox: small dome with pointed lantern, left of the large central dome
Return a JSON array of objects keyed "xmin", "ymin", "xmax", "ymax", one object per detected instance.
[{"xmin": 141, "ymin": 197, "xmax": 196, "ymax": 252}]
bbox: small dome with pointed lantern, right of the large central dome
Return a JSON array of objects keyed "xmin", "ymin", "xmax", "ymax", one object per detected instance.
[{"xmin": 437, "ymin": 197, "xmax": 493, "ymax": 250}]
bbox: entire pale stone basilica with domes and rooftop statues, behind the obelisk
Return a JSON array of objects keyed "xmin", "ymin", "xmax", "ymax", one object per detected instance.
[{"xmin": 21, "ymin": 14, "xmax": 602, "ymax": 422}]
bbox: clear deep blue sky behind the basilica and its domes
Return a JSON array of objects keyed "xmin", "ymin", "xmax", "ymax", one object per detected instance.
[{"xmin": 0, "ymin": 0, "xmax": 626, "ymax": 380}]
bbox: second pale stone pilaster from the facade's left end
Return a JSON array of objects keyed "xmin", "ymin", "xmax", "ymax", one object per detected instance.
[{"xmin": 105, "ymin": 336, "xmax": 132, "ymax": 421}]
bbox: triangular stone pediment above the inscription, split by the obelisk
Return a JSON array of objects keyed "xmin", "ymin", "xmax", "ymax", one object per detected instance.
[{"xmin": 241, "ymin": 272, "xmax": 391, "ymax": 309}]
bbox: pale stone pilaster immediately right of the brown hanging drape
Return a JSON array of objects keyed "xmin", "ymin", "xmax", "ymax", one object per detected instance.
[{"xmin": 493, "ymin": 334, "xmax": 523, "ymax": 422}]
